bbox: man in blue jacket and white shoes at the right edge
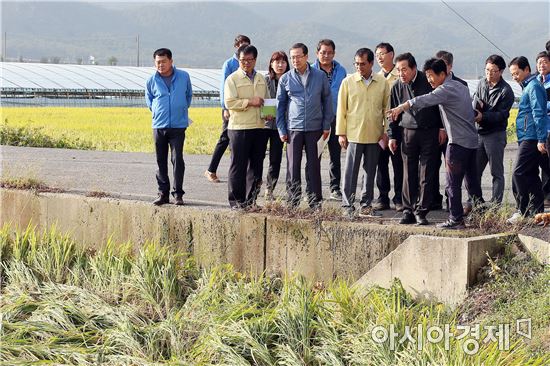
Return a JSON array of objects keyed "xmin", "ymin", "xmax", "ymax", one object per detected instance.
[{"xmin": 508, "ymin": 56, "xmax": 548, "ymax": 224}]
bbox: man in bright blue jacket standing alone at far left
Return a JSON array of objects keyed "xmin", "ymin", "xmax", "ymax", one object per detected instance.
[{"xmin": 145, "ymin": 48, "xmax": 193, "ymax": 206}]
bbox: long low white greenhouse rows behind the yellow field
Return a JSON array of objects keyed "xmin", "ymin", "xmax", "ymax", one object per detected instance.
[{"xmin": 0, "ymin": 62, "xmax": 521, "ymax": 107}]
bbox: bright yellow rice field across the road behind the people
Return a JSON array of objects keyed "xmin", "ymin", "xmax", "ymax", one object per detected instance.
[{"xmin": 0, "ymin": 107, "xmax": 517, "ymax": 154}]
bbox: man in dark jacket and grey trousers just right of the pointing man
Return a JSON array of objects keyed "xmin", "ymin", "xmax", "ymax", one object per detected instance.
[{"xmin": 467, "ymin": 55, "xmax": 514, "ymax": 208}]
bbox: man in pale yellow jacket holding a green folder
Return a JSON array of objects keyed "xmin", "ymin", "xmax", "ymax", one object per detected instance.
[{"xmin": 224, "ymin": 45, "xmax": 269, "ymax": 209}]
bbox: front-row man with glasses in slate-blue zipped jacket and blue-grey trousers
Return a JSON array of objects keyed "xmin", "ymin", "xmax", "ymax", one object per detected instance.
[{"xmin": 276, "ymin": 43, "xmax": 334, "ymax": 209}]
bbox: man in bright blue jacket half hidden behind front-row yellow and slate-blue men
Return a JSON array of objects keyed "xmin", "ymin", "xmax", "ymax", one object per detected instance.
[{"xmin": 312, "ymin": 39, "xmax": 347, "ymax": 201}]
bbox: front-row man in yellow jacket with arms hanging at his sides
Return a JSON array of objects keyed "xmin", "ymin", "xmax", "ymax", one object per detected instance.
[{"xmin": 336, "ymin": 48, "xmax": 390, "ymax": 217}]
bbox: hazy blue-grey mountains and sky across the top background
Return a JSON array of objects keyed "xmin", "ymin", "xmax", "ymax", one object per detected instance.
[{"xmin": 0, "ymin": 1, "xmax": 550, "ymax": 78}]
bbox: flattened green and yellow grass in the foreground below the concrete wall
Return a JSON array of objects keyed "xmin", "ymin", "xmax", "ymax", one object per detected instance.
[{"xmin": 0, "ymin": 226, "xmax": 550, "ymax": 366}]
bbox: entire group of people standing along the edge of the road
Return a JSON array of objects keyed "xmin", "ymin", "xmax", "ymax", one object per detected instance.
[{"xmin": 146, "ymin": 35, "xmax": 550, "ymax": 229}]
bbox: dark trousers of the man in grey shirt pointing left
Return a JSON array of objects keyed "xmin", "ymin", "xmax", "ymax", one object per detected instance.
[{"xmin": 445, "ymin": 144, "xmax": 483, "ymax": 221}]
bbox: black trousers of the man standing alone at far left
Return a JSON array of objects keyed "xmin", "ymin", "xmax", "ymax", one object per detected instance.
[{"xmin": 153, "ymin": 128, "xmax": 185, "ymax": 196}]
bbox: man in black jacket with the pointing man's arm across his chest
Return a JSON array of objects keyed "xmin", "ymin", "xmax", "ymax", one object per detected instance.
[{"xmin": 388, "ymin": 53, "xmax": 446, "ymax": 225}]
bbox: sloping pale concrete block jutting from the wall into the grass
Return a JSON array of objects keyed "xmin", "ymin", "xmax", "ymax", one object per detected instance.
[{"xmin": 355, "ymin": 234, "xmax": 513, "ymax": 306}]
